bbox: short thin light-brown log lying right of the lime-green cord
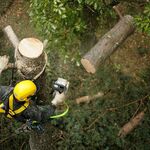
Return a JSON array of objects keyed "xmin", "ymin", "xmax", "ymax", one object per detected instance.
[{"xmin": 76, "ymin": 92, "xmax": 104, "ymax": 104}]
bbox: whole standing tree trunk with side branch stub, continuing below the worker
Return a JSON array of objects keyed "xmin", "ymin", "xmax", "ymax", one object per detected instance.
[{"xmin": 4, "ymin": 26, "xmax": 54, "ymax": 150}]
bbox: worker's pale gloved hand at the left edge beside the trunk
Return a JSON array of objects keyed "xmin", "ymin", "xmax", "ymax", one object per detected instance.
[{"xmin": 0, "ymin": 55, "xmax": 9, "ymax": 73}]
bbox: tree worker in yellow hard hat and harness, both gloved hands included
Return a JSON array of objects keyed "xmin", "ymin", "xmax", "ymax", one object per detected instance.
[{"xmin": 0, "ymin": 56, "xmax": 69, "ymax": 132}]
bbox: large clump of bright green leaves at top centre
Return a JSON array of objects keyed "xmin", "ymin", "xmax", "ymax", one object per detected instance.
[{"xmin": 29, "ymin": 0, "xmax": 115, "ymax": 57}]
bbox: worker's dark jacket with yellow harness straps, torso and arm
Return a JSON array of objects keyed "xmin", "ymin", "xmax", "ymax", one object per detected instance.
[{"xmin": 0, "ymin": 86, "xmax": 55, "ymax": 122}]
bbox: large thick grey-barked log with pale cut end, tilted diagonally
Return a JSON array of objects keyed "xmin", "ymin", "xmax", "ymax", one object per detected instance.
[{"xmin": 81, "ymin": 15, "xmax": 135, "ymax": 73}]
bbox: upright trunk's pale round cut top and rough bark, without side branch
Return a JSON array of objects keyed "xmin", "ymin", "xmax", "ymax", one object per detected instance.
[{"xmin": 16, "ymin": 38, "xmax": 47, "ymax": 79}]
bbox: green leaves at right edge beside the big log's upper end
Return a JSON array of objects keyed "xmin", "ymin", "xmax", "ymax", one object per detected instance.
[{"xmin": 135, "ymin": 3, "xmax": 150, "ymax": 34}]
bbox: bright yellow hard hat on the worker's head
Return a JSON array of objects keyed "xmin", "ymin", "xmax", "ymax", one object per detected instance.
[{"xmin": 13, "ymin": 80, "xmax": 37, "ymax": 101}]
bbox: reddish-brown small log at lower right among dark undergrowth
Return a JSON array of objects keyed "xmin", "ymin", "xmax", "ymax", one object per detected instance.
[{"xmin": 118, "ymin": 111, "xmax": 145, "ymax": 137}]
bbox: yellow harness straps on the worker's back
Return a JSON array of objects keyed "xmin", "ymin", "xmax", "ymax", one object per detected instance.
[{"xmin": 0, "ymin": 94, "xmax": 29, "ymax": 118}]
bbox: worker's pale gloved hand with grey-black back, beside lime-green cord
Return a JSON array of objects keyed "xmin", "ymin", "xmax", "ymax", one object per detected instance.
[{"xmin": 52, "ymin": 78, "xmax": 69, "ymax": 106}]
